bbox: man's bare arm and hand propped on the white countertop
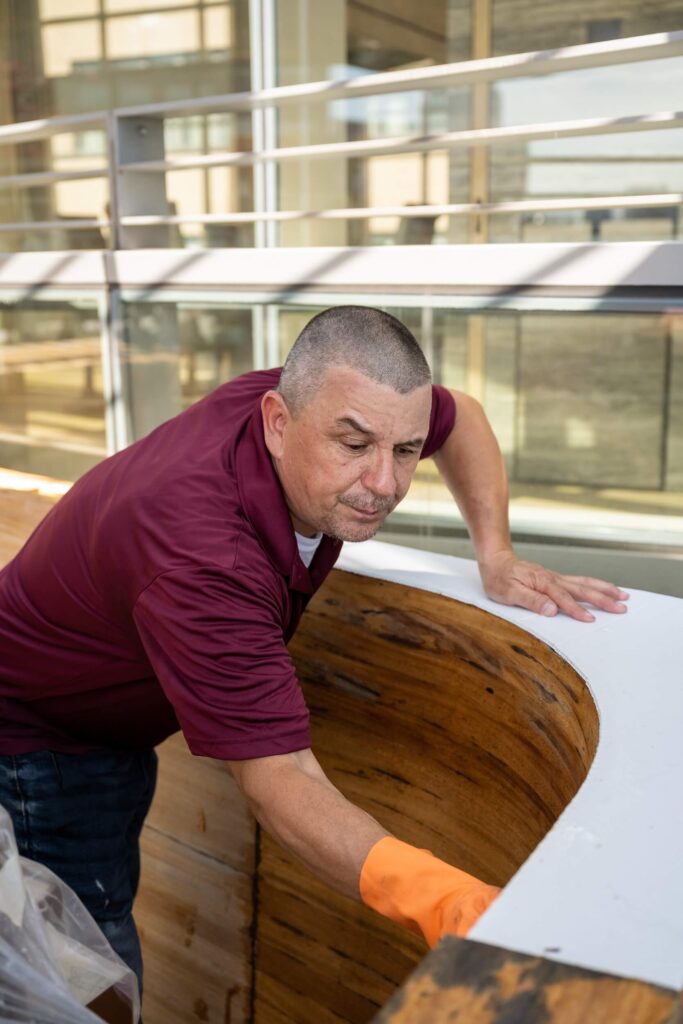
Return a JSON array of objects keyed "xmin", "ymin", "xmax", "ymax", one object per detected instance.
[{"xmin": 434, "ymin": 391, "xmax": 629, "ymax": 623}]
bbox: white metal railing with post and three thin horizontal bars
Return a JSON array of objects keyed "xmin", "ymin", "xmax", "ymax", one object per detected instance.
[{"xmin": 0, "ymin": 31, "xmax": 683, "ymax": 243}]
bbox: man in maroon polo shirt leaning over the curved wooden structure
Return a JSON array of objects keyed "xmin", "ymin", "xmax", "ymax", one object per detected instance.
[{"xmin": 0, "ymin": 306, "xmax": 627, "ymax": 991}]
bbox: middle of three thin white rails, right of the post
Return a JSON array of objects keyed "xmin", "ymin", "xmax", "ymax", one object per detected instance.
[{"xmin": 119, "ymin": 111, "xmax": 683, "ymax": 174}]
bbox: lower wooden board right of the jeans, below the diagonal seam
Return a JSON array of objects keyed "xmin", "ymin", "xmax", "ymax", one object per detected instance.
[{"xmin": 135, "ymin": 827, "xmax": 252, "ymax": 1024}]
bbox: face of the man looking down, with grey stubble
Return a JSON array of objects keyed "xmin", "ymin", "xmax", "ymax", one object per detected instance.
[{"xmin": 262, "ymin": 367, "xmax": 432, "ymax": 541}]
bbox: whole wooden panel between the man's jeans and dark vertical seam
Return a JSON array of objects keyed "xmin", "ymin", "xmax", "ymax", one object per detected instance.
[{"xmin": 135, "ymin": 733, "xmax": 256, "ymax": 1024}]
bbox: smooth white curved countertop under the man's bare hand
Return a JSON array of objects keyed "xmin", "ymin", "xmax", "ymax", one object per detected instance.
[{"xmin": 338, "ymin": 541, "xmax": 683, "ymax": 989}]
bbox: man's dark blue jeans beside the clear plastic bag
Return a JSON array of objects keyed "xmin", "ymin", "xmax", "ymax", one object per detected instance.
[{"xmin": 0, "ymin": 750, "xmax": 157, "ymax": 992}]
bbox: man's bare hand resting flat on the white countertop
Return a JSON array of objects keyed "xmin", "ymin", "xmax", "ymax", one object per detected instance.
[{"xmin": 479, "ymin": 551, "xmax": 629, "ymax": 623}]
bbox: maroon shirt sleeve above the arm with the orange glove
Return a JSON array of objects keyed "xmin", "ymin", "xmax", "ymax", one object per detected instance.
[{"xmin": 133, "ymin": 567, "xmax": 310, "ymax": 761}]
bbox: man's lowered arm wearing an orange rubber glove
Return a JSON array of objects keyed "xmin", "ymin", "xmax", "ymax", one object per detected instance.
[{"xmin": 228, "ymin": 750, "xmax": 499, "ymax": 945}]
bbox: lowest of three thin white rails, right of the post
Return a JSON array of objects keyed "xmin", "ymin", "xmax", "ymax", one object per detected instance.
[{"xmin": 121, "ymin": 193, "xmax": 683, "ymax": 227}]
